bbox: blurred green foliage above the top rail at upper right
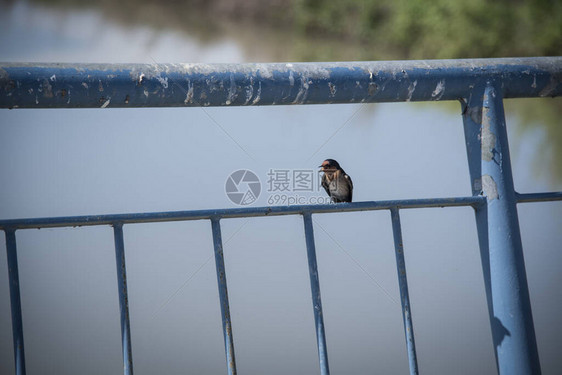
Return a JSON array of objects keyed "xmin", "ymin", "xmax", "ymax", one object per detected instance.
[{"xmin": 293, "ymin": 0, "xmax": 562, "ymax": 58}]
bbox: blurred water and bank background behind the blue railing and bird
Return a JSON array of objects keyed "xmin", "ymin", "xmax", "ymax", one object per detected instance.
[{"xmin": 0, "ymin": 0, "xmax": 562, "ymax": 374}]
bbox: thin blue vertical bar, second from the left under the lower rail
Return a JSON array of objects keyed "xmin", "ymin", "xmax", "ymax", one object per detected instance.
[{"xmin": 113, "ymin": 223, "xmax": 133, "ymax": 375}]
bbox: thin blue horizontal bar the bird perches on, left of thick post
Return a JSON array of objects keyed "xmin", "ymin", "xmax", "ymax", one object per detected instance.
[{"xmin": 0, "ymin": 196, "xmax": 486, "ymax": 229}]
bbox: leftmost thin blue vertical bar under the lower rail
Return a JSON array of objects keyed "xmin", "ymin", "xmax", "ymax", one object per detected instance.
[{"xmin": 5, "ymin": 229, "xmax": 25, "ymax": 375}]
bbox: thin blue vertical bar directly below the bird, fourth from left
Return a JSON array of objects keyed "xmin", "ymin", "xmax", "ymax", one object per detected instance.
[{"xmin": 303, "ymin": 213, "xmax": 330, "ymax": 375}]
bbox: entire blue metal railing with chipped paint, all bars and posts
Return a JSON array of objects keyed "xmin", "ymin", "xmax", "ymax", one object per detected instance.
[{"xmin": 0, "ymin": 57, "xmax": 562, "ymax": 374}]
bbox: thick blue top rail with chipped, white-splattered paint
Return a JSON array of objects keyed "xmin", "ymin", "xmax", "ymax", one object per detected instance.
[{"xmin": 0, "ymin": 57, "xmax": 562, "ymax": 108}]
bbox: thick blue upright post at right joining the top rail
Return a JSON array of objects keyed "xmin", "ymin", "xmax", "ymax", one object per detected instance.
[{"xmin": 463, "ymin": 83, "xmax": 541, "ymax": 375}]
